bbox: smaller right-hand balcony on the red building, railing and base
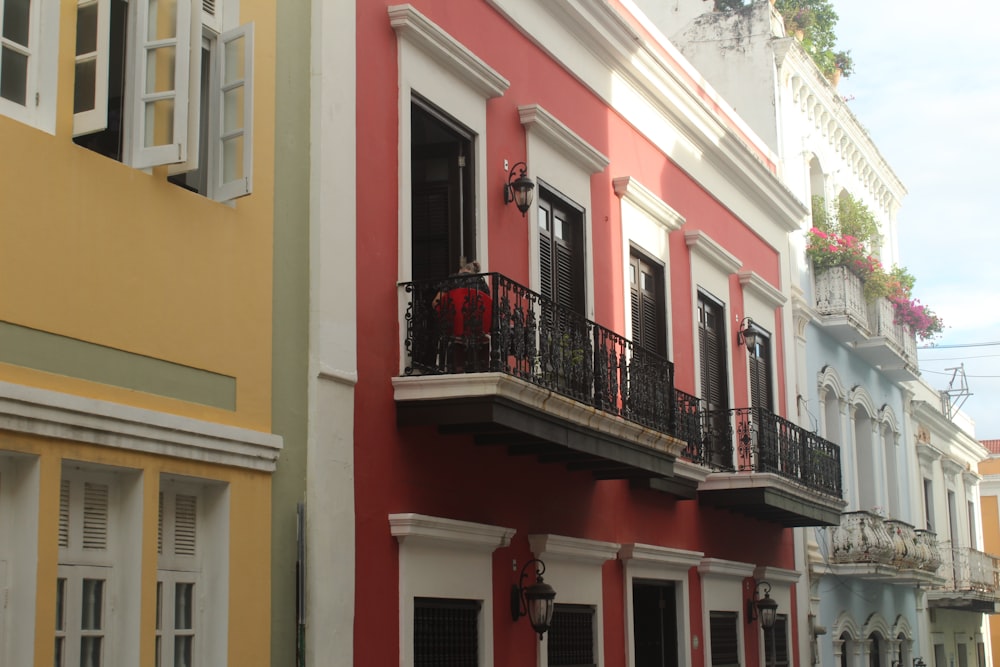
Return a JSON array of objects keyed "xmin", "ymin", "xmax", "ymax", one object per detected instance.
[{"xmin": 697, "ymin": 408, "xmax": 846, "ymax": 526}]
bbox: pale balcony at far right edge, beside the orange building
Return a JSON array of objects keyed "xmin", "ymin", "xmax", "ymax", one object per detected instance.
[{"xmin": 927, "ymin": 542, "xmax": 1000, "ymax": 614}]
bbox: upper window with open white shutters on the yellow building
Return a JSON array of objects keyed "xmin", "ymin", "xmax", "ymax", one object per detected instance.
[{"xmin": 73, "ymin": 0, "xmax": 253, "ymax": 201}]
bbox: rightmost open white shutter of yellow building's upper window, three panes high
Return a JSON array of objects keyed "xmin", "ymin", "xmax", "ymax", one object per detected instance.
[{"xmin": 212, "ymin": 23, "xmax": 253, "ymax": 201}]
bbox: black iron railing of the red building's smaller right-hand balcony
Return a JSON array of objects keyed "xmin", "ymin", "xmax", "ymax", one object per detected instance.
[{"xmin": 705, "ymin": 408, "xmax": 843, "ymax": 498}]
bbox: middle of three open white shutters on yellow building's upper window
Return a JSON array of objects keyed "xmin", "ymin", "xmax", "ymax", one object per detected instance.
[{"xmin": 130, "ymin": 0, "xmax": 191, "ymax": 169}]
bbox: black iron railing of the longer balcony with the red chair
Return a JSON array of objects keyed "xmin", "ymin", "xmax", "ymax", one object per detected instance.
[{"xmin": 402, "ymin": 273, "xmax": 689, "ymax": 435}]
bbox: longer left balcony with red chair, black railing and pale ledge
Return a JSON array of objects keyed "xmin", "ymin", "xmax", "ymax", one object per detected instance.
[{"xmin": 393, "ymin": 274, "xmax": 692, "ymax": 490}]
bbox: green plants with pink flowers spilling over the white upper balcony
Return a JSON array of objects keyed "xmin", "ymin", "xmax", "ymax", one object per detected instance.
[{"xmin": 806, "ymin": 194, "xmax": 944, "ymax": 340}]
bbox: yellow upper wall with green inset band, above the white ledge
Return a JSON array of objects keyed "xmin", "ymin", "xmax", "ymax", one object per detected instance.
[{"xmin": 0, "ymin": 0, "xmax": 275, "ymax": 431}]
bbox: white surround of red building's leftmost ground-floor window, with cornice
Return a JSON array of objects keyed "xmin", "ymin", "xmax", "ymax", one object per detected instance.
[{"xmin": 389, "ymin": 513, "xmax": 515, "ymax": 667}]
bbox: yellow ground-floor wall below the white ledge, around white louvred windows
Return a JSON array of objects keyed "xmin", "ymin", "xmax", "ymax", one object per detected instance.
[{"xmin": 0, "ymin": 435, "xmax": 271, "ymax": 667}]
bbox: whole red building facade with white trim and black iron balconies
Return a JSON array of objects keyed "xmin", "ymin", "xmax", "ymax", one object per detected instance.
[{"xmin": 354, "ymin": 0, "xmax": 843, "ymax": 667}]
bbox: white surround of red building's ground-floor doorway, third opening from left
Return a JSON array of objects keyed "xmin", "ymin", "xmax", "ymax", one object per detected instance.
[{"xmin": 618, "ymin": 544, "xmax": 705, "ymax": 667}]
